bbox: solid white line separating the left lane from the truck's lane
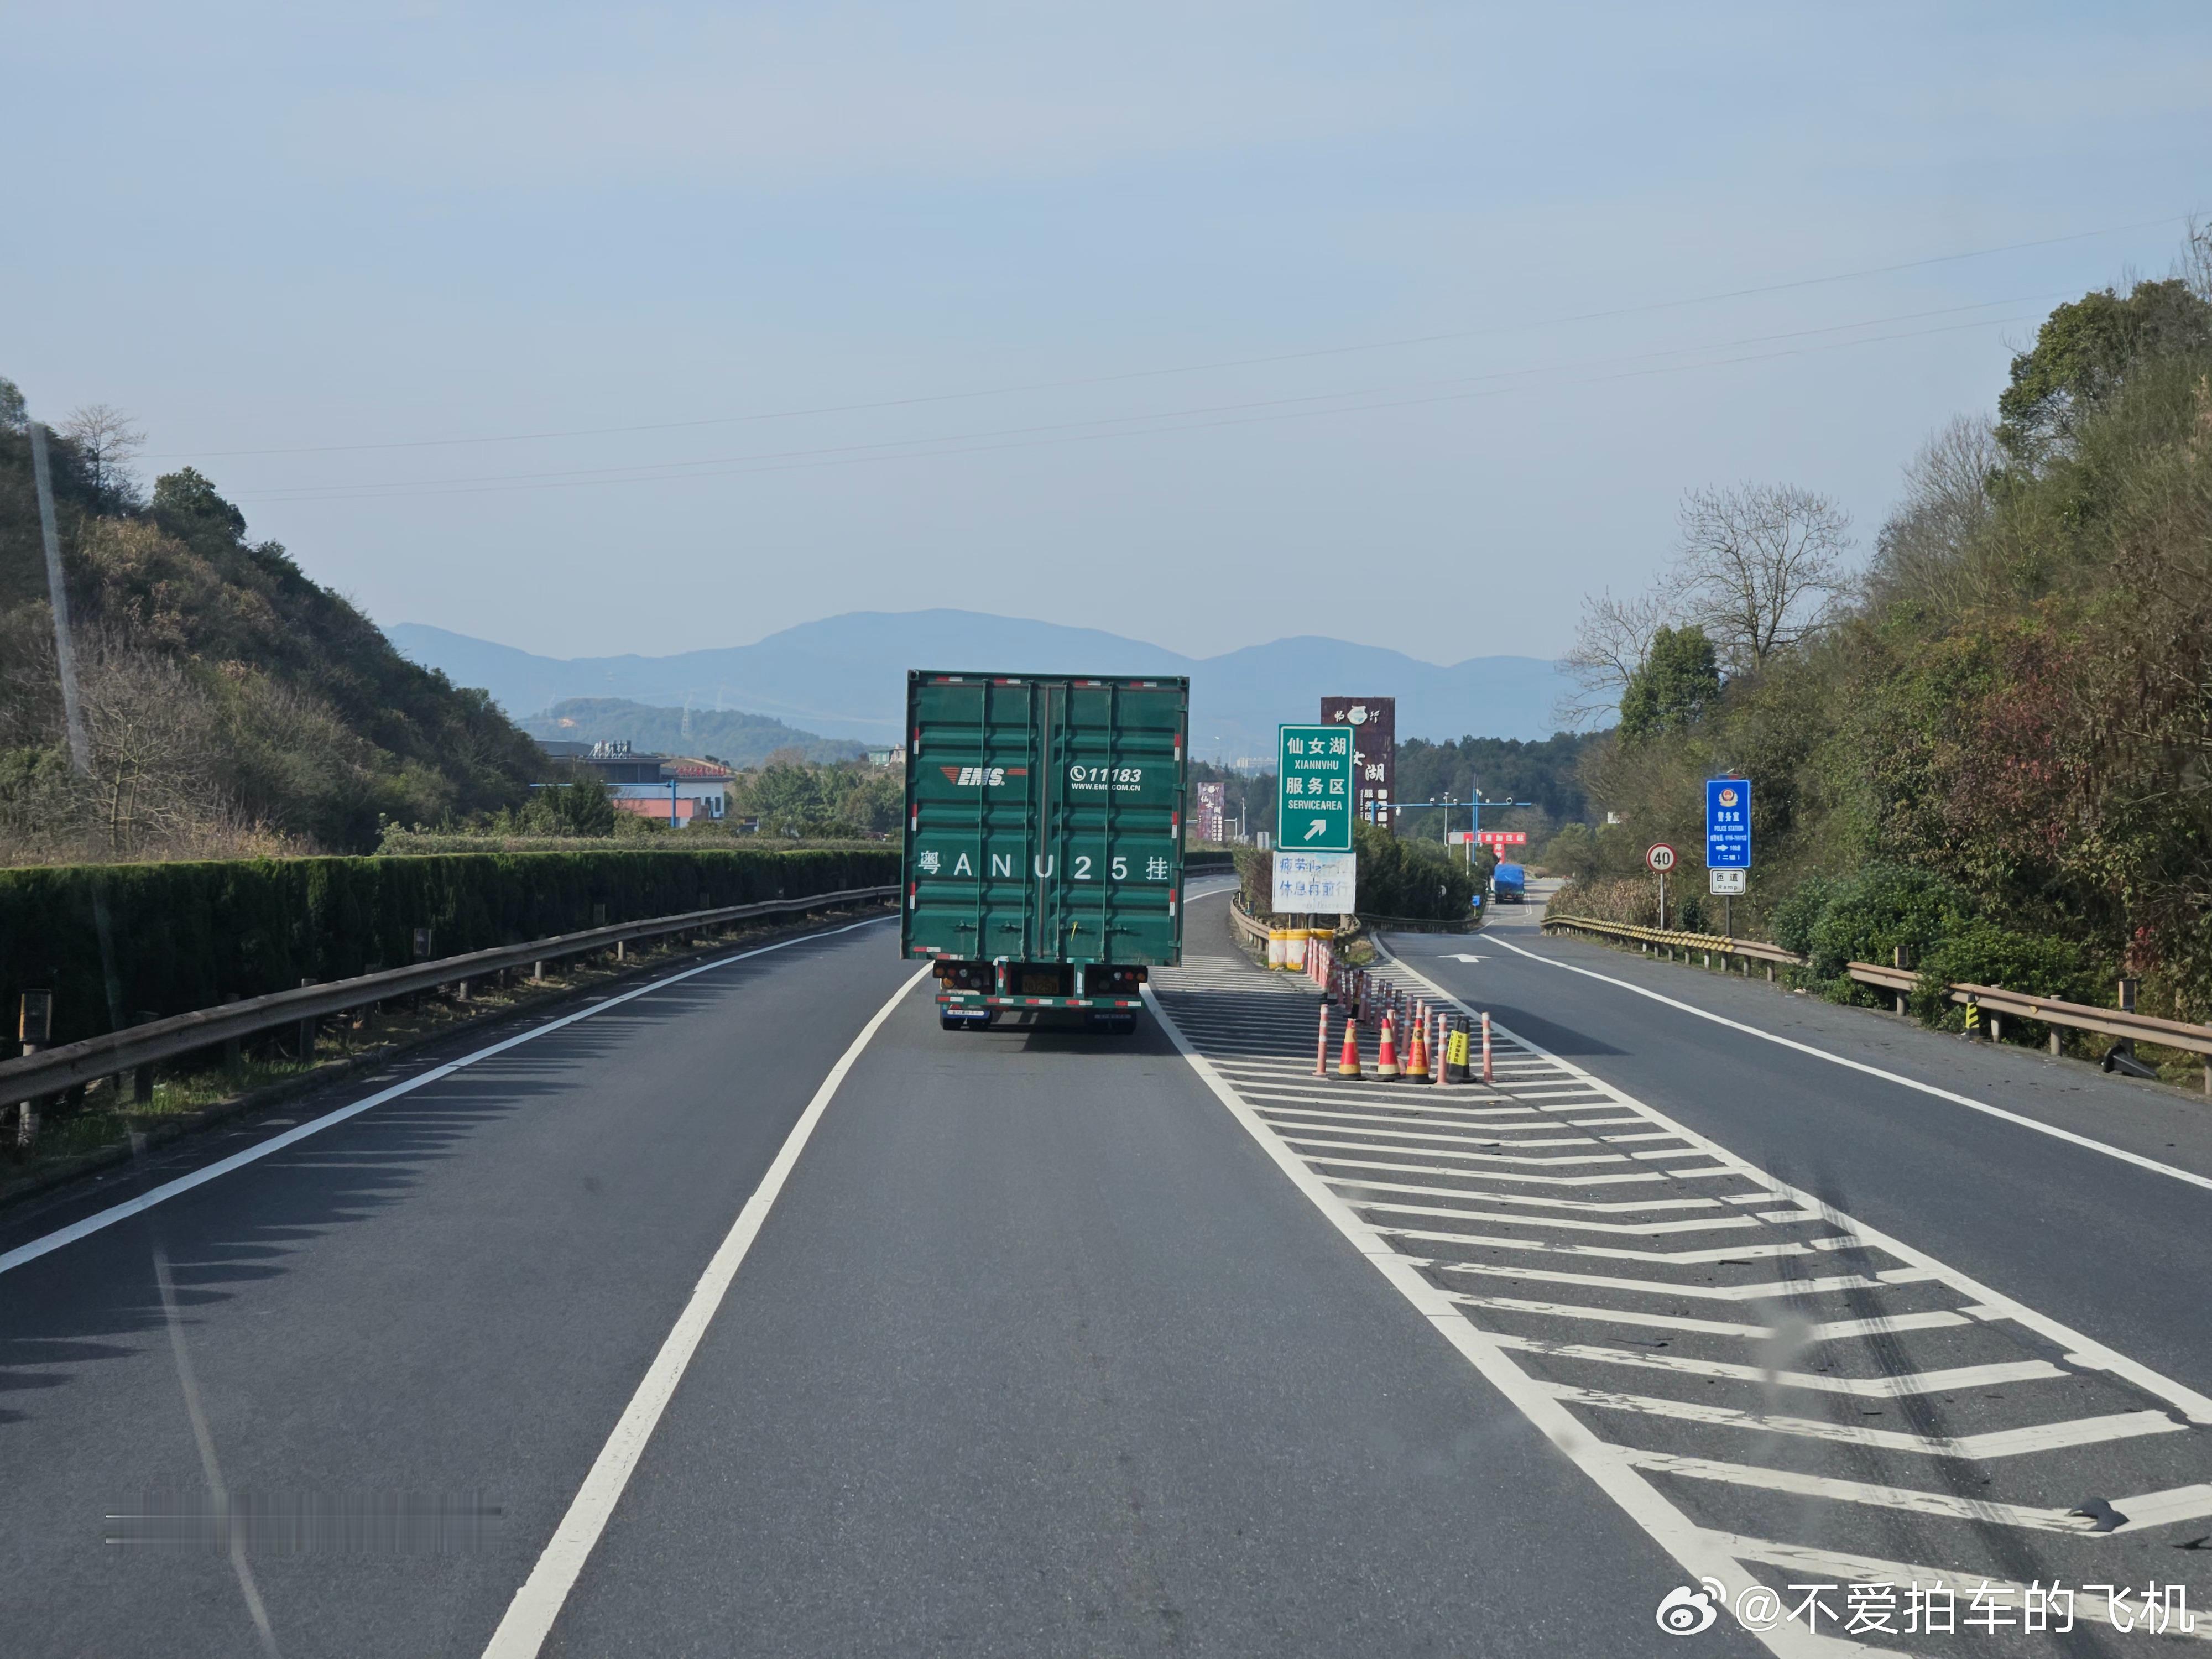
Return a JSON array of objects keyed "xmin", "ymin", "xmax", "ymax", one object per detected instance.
[{"xmin": 484, "ymin": 962, "xmax": 933, "ymax": 1659}]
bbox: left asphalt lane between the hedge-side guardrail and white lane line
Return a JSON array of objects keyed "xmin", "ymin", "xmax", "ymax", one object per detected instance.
[{"xmin": 0, "ymin": 920, "xmax": 911, "ymax": 1657}]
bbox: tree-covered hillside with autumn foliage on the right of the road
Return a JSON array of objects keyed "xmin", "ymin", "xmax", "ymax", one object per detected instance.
[{"xmin": 1546, "ymin": 252, "xmax": 2212, "ymax": 1020}]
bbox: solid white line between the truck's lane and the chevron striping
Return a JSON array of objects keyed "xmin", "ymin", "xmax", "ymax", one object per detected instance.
[{"xmin": 1141, "ymin": 984, "xmax": 1867, "ymax": 1659}]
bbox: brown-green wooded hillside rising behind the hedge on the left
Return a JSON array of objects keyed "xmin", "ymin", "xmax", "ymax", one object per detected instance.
[{"xmin": 0, "ymin": 380, "xmax": 538, "ymax": 863}]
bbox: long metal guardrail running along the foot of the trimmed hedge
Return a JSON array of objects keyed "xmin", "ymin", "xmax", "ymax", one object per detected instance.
[{"xmin": 0, "ymin": 883, "xmax": 900, "ymax": 1106}]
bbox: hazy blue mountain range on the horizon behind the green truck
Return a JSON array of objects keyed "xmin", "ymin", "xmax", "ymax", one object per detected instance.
[{"xmin": 385, "ymin": 611, "xmax": 1568, "ymax": 761}]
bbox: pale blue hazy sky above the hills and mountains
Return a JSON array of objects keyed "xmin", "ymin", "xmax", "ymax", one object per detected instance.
[{"xmin": 0, "ymin": 0, "xmax": 2212, "ymax": 661}]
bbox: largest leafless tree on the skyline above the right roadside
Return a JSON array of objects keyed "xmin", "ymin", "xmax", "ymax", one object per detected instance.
[{"xmin": 1674, "ymin": 484, "xmax": 1851, "ymax": 675}]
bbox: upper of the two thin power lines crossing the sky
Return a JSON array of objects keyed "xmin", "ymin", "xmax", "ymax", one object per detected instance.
[{"xmin": 148, "ymin": 215, "xmax": 2190, "ymax": 460}]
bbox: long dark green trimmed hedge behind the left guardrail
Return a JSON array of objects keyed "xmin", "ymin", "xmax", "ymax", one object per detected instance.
[{"xmin": 0, "ymin": 847, "xmax": 898, "ymax": 1053}]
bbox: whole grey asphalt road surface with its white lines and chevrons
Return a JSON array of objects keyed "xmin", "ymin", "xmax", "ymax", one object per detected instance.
[{"xmin": 0, "ymin": 894, "xmax": 2212, "ymax": 1657}]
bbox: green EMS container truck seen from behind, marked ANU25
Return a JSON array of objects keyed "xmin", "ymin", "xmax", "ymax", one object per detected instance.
[{"xmin": 900, "ymin": 670, "xmax": 1190, "ymax": 1033}]
